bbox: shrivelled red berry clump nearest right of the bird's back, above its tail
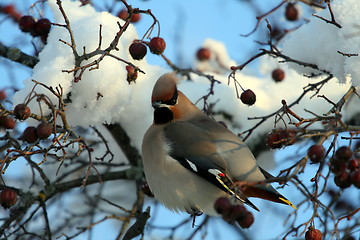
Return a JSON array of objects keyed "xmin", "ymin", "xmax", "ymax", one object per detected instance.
[{"xmin": 266, "ymin": 128, "xmax": 296, "ymax": 149}]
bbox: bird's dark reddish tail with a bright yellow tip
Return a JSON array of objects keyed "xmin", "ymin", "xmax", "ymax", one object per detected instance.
[{"xmin": 242, "ymin": 184, "xmax": 297, "ymax": 209}]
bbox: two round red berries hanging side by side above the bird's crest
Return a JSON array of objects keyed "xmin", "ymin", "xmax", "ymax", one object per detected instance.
[{"xmin": 129, "ymin": 37, "xmax": 166, "ymax": 60}]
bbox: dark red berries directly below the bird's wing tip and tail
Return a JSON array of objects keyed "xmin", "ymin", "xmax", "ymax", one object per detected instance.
[{"xmin": 214, "ymin": 197, "xmax": 254, "ymax": 228}]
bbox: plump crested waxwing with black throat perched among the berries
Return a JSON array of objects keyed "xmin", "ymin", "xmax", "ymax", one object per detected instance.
[{"xmin": 142, "ymin": 73, "xmax": 296, "ymax": 216}]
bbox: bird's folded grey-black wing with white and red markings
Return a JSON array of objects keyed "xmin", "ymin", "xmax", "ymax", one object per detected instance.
[{"xmin": 164, "ymin": 121, "xmax": 258, "ymax": 210}]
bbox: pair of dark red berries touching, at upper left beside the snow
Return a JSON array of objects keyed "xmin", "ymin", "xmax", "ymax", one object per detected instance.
[{"xmin": 19, "ymin": 15, "xmax": 51, "ymax": 43}]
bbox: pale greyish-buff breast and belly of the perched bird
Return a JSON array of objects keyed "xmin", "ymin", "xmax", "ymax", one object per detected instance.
[{"xmin": 142, "ymin": 126, "xmax": 225, "ymax": 215}]
